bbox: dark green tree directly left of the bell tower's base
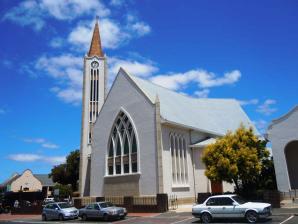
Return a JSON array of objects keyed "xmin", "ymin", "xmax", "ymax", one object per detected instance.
[{"xmin": 49, "ymin": 150, "xmax": 80, "ymax": 191}]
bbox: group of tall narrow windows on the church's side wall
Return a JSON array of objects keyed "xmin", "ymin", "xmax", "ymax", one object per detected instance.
[{"xmin": 170, "ymin": 133, "xmax": 188, "ymax": 186}]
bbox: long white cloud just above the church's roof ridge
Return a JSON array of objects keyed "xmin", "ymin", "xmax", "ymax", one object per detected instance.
[{"xmin": 151, "ymin": 69, "xmax": 241, "ymax": 90}]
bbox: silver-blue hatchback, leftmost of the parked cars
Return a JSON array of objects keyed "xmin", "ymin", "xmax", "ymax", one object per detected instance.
[{"xmin": 42, "ymin": 202, "xmax": 79, "ymax": 221}]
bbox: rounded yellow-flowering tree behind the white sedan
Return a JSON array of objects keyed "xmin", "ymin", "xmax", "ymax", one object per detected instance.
[{"xmin": 202, "ymin": 125, "xmax": 269, "ymax": 192}]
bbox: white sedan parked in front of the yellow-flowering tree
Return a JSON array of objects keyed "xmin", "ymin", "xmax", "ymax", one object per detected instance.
[{"xmin": 192, "ymin": 194, "xmax": 271, "ymax": 223}]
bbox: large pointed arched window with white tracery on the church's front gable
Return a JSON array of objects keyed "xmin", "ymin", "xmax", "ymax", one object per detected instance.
[{"xmin": 107, "ymin": 111, "xmax": 138, "ymax": 175}]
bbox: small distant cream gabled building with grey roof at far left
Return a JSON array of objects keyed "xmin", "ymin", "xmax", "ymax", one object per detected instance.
[{"xmin": 0, "ymin": 169, "xmax": 54, "ymax": 196}]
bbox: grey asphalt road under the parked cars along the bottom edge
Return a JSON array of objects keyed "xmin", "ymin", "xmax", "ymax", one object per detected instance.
[{"xmin": 0, "ymin": 212, "xmax": 298, "ymax": 224}]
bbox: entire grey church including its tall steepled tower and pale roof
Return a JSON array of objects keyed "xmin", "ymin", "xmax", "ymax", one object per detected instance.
[{"xmin": 80, "ymin": 19, "xmax": 253, "ymax": 198}]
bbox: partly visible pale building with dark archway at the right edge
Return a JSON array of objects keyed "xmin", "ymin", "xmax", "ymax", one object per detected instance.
[{"xmin": 267, "ymin": 106, "xmax": 298, "ymax": 192}]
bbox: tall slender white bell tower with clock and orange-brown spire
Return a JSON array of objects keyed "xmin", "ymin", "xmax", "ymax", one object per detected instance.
[{"xmin": 79, "ymin": 18, "xmax": 107, "ymax": 196}]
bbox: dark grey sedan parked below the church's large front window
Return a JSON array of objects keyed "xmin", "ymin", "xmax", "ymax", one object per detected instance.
[{"xmin": 79, "ymin": 202, "xmax": 127, "ymax": 221}]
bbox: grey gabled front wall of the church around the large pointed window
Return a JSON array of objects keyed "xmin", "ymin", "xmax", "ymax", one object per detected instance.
[{"xmin": 91, "ymin": 68, "xmax": 157, "ymax": 195}]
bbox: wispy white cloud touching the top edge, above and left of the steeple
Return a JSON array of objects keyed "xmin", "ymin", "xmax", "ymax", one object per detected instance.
[{"xmin": 3, "ymin": 0, "xmax": 110, "ymax": 31}]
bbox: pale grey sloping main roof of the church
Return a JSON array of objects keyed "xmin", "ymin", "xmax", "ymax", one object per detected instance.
[{"xmin": 120, "ymin": 69, "xmax": 259, "ymax": 136}]
